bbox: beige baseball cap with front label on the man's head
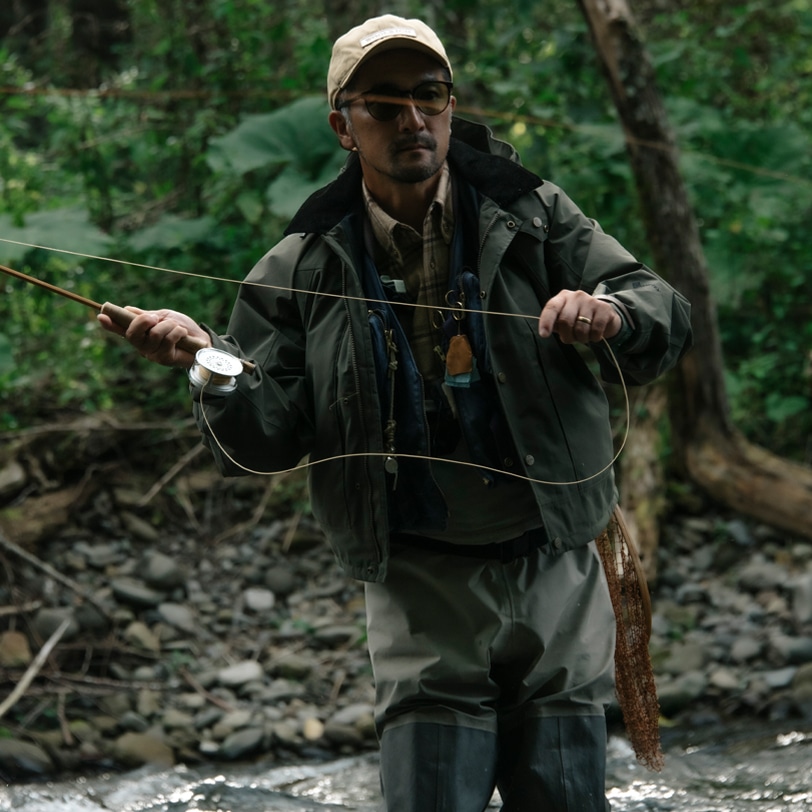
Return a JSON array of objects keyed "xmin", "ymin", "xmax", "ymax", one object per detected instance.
[{"xmin": 327, "ymin": 14, "xmax": 451, "ymax": 107}]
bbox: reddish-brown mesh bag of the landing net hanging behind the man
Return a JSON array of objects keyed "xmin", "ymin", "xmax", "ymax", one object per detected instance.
[{"xmin": 597, "ymin": 507, "xmax": 663, "ymax": 771}]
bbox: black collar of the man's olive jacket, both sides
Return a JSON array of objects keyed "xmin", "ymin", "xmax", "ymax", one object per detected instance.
[{"xmin": 285, "ymin": 118, "xmax": 543, "ymax": 234}]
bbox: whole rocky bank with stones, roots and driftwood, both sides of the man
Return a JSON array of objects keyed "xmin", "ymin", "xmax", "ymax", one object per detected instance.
[{"xmin": 0, "ymin": 417, "xmax": 812, "ymax": 782}]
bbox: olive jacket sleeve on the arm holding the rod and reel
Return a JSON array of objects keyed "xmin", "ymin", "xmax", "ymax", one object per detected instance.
[{"xmin": 193, "ymin": 237, "xmax": 314, "ymax": 476}]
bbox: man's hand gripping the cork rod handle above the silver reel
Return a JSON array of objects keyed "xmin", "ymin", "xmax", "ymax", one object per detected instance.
[{"xmin": 97, "ymin": 307, "xmax": 211, "ymax": 369}]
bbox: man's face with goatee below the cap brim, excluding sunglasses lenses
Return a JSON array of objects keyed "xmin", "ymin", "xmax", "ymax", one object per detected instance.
[{"xmin": 330, "ymin": 49, "xmax": 455, "ymax": 189}]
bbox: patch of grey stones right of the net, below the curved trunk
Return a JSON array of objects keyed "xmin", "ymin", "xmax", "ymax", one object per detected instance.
[{"xmin": 650, "ymin": 517, "xmax": 812, "ymax": 723}]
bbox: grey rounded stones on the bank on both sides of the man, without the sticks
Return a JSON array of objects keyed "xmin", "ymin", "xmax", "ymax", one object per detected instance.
[{"xmin": 0, "ymin": 494, "xmax": 812, "ymax": 776}]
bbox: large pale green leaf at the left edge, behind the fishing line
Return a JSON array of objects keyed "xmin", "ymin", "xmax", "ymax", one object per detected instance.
[{"xmin": 0, "ymin": 208, "xmax": 113, "ymax": 263}]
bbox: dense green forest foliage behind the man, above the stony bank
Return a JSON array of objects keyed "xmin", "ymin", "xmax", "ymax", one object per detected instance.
[{"xmin": 0, "ymin": 0, "xmax": 812, "ymax": 463}]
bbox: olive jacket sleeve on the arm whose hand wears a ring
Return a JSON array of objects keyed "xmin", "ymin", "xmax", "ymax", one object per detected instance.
[{"xmin": 539, "ymin": 182, "xmax": 692, "ymax": 385}]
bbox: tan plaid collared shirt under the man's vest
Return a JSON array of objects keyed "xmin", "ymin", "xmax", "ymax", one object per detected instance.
[{"xmin": 364, "ymin": 164, "xmax": 454, "ymax": 381}]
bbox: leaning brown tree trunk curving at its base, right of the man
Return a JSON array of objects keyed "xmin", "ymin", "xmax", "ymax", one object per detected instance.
[{"xmin": 578, "ymin": 0, "xmax": 812, "ymax": 538}]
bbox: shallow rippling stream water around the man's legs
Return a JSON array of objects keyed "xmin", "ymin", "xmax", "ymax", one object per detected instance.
[{"xmin": 0, "ymin": 722, "xmax": 812, "ymax": 812}]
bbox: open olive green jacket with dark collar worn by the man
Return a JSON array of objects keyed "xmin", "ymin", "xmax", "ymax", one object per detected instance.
[{"xmin": 195, "ymin": 120, "xmax": 691, "ymax": 581}]
